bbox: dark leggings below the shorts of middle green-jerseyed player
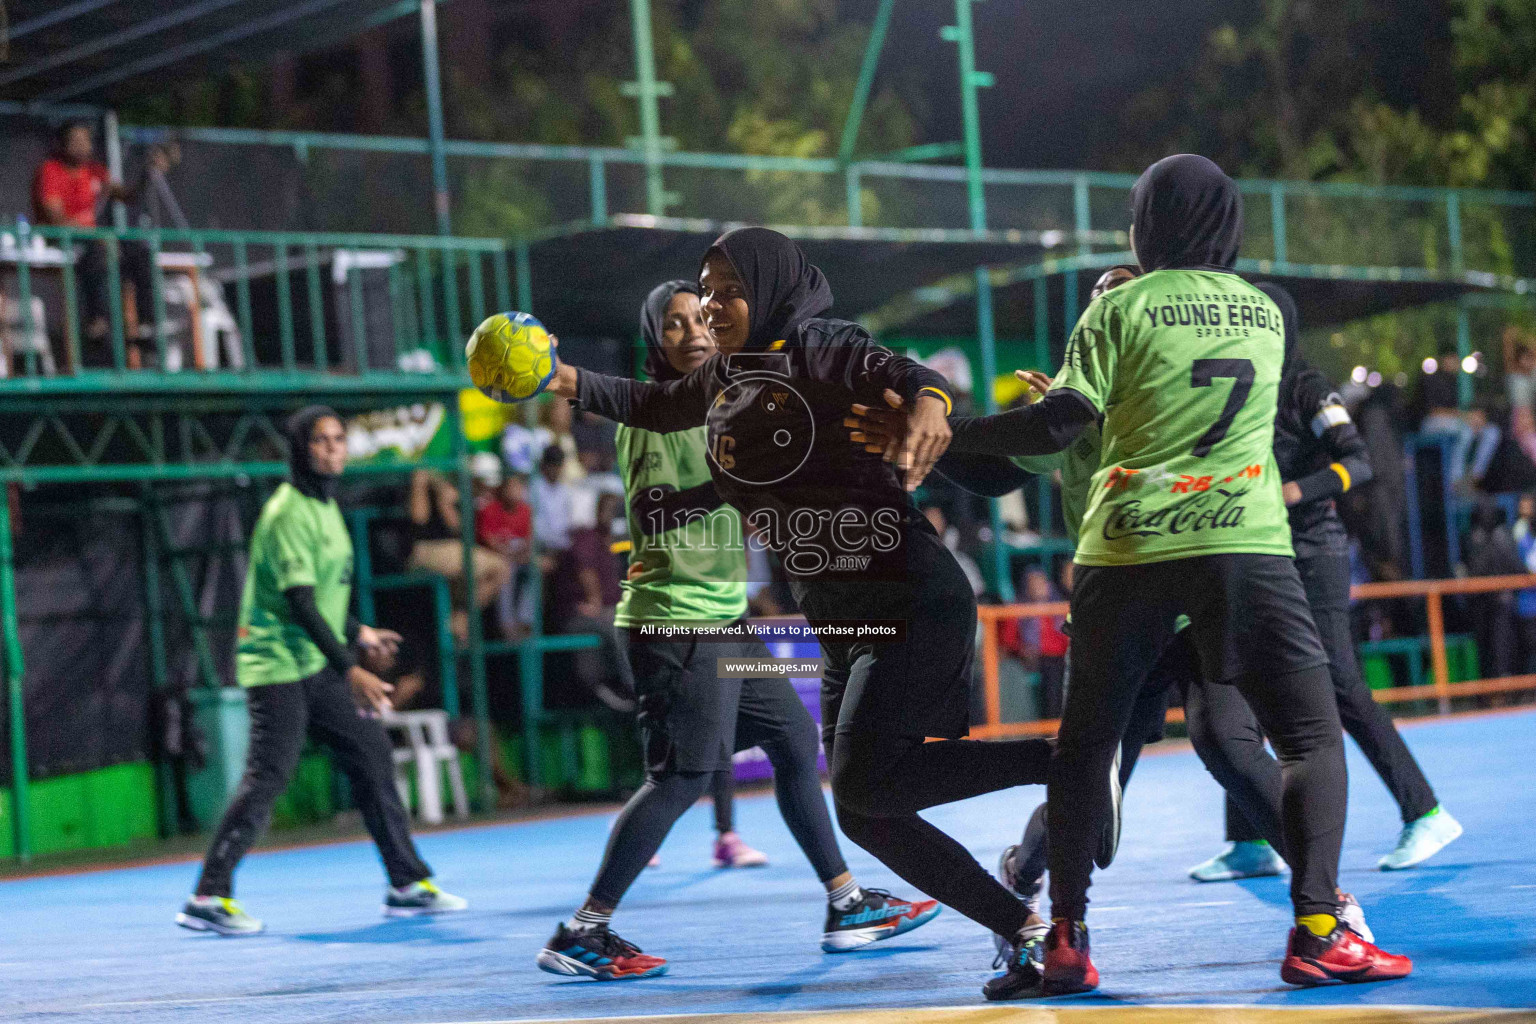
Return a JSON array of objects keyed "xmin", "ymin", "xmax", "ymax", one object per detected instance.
[{"xmin": 590, "ymin": 675, "xmax": 848, "ymax": 907}]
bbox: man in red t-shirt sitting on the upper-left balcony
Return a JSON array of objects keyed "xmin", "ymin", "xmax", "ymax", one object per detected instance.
[{"xmin": 32, "ymin": 121, "xmax": 154, "ymax": 364}]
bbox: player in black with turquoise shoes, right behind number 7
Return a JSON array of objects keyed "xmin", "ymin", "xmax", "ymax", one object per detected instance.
[{"xmin": 1189, "ymin": 284, "xmax": 1461, "ymax": 881}]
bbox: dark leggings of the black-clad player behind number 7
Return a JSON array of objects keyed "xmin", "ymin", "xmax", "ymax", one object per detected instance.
[{"xmin": 1216, "ymin": 554, "xmax": 1439, "ymax": 843}]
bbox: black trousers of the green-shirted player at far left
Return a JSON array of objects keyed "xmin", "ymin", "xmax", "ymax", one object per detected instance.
[{"xmin": 197, "ymin": 668, "xmax": 432, "ymax": 897}]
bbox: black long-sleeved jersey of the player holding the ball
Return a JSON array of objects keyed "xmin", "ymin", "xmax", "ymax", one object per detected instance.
[{"xmin": 576, "ymin": 318, "xmax": 949, "ymax": 579}]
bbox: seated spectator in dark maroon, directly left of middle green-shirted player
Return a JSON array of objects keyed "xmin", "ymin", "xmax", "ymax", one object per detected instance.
[{"xmin": 548, "ymin": 494, "xmax": 634, "ymax": 711}]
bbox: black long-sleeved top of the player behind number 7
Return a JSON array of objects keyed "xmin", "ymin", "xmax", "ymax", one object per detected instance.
[{"xmin": 1275, "ymin": 365, "xmax": 1372, "ymax": 559}]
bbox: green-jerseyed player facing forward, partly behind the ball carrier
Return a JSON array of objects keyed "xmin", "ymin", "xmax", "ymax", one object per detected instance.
[{"xmin": 538, "ymin": 281, "xmax": 940, "ymax": 979}]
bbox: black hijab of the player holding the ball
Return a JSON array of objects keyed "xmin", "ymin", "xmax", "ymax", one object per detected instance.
[{"xmin": 705, "ymin": 227, "xmax": 833, "ymax": 352}]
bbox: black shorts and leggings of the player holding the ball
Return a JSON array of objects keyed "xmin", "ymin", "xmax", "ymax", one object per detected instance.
[{"xmin": 794, "ymin": 530, "xmax": 1052, "ymax": 938}]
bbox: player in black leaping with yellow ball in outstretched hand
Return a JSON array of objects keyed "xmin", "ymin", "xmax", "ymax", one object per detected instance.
[{"xmin": 550, "ymin": 227, "xmax": 1052, "ymax": 982}]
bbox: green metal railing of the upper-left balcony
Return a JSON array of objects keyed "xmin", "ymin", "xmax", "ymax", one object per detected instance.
[{"xmin": 0, "ymin": 221, "xmax": 511, "ymax": 383}]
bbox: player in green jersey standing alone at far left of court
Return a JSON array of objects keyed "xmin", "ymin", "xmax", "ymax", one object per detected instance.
[{"xmin": 177, "ymin": 405, "xmax": 468, "ymax": 935}]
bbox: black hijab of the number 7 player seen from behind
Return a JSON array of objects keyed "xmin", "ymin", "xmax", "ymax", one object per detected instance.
[{"xmin": 1130, "ymin": 154, "xmax": 1243, "ymax": 272}]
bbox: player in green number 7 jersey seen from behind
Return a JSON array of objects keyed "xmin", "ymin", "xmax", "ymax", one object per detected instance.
[{"xmin": 915, "ymin": 155, "xmax": 1412, "ymax": 993}]
